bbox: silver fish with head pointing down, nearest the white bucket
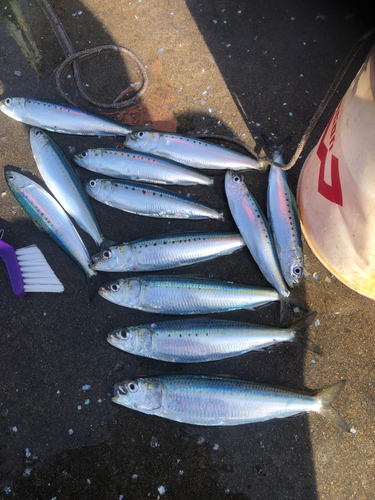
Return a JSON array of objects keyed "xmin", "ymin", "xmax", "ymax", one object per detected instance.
[{"xmin": 263, "ymin": 136, "xmax": 303, "ymax": 288}]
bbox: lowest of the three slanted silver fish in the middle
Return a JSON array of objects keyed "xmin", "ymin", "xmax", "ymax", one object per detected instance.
[{"xmin": 86, "ymin": 179, "xmax": 224, "ymax": 220}]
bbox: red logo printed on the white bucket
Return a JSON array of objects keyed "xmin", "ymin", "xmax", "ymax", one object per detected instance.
[{"xmin": 316, "ymin": 101, "xmax": 342, "ymax": 207}]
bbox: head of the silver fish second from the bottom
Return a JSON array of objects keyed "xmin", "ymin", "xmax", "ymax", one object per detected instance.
[{"xmin": 107, "ymin": 326, "xmax": 152, "ymax": 355}]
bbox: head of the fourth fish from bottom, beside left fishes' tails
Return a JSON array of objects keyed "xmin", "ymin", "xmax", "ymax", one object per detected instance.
[{"xmin": 90, "ymin": 244, "xmax": 134, "ymax": 272}]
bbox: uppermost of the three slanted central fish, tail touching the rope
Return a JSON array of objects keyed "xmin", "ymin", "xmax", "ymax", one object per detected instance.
[{"xmin": 124, "ymin": 131, "xmax": 264, "ymax": 170}]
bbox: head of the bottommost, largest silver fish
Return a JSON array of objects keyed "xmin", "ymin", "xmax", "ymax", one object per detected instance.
[{"xmin": 112, "ymin": 377, "xmax": 163, "ymax": 413}]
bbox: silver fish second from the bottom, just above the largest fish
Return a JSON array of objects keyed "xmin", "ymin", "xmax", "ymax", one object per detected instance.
[{"xmin": 107, "ymin": 317, "xmax": 318, "ymax": 363}]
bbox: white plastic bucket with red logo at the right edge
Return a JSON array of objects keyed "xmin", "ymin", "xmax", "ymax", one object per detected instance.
[{"xmin": 297, "ymin": 46, "xmax": 375, "ymax": 299}]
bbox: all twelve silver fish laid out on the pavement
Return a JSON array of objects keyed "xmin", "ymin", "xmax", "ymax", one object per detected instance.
[{"xmin": 0, "ymin": 98, "xmax": 349, "ymax": 431}]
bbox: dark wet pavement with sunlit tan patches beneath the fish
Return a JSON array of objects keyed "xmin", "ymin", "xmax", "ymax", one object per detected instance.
[{"xmin": 0, "ymin": 0, "xmax": 375, "ymax": 500}]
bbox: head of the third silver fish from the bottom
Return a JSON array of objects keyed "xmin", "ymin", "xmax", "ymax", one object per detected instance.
[{"xmin": 98, "ymin": 278, "xmax": 142, "ymax": 307}]
